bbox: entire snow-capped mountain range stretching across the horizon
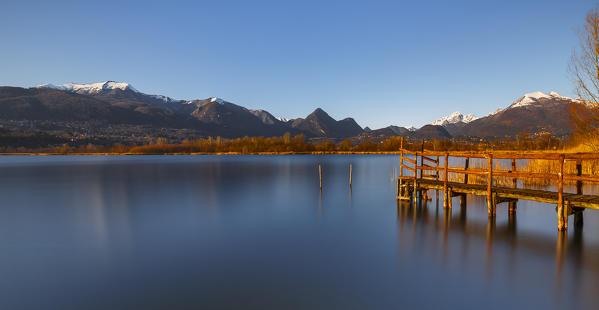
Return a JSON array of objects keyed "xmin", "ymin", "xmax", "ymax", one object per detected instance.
[{"xmin": 0, "ymin": 81, "xmax": 592, "ymax": 147}]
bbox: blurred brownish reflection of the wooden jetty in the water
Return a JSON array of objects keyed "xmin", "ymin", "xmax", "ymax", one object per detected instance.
[{"xmin": 397, "ymin": 191, "xmax": 599, "ymax": 306}]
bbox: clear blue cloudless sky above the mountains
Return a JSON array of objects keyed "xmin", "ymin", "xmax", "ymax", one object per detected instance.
[{"xmin": 0, "ymin": 0, "xmax": 596, "ymax": 128}]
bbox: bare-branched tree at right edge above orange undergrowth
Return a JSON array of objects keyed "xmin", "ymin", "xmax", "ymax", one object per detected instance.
[{"xmin": 569, "ymin": 7, "xmax": 599, "ymax": 151}]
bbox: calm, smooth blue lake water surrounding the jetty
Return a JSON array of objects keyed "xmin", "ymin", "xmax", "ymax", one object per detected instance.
[{"xmin": 0, "ymin": 156, "xmax": 599, "ymax": 309}]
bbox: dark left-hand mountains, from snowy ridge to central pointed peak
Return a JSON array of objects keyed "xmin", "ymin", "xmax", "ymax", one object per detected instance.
[{"xmin": 0, "ymin": 81, "xmax": 363, "ymax": 143}]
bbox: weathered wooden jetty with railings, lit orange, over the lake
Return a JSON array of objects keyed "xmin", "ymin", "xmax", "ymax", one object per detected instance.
[{"xmin": 397, "ymin": 147, "xmax": 599, "ymax": 230}]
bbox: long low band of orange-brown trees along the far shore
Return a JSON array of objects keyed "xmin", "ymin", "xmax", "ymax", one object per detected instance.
[{"xmin": 0, "ymin": 132, "xmax": 564, "ymax": 154}]
